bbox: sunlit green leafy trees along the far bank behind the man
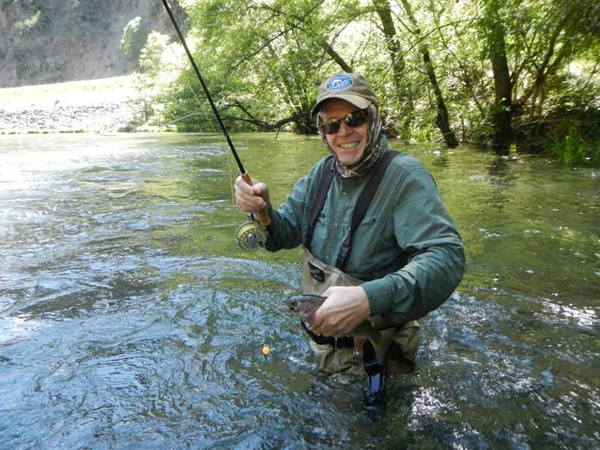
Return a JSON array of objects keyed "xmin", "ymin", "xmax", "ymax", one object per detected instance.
[{"xmin": 138, "ymin": 0, "xmax": 600, "ymax": 162}]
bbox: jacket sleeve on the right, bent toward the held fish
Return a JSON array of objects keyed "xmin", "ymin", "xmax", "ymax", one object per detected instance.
[{"xmin": 362, "ymin": 168, "xmax": 465, "ymax": 324}]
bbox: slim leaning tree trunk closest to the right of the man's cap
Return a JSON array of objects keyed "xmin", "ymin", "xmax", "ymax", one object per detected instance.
[{"xmin": 373, "ymin": 0, "xmax": 415, "ymax": 140}]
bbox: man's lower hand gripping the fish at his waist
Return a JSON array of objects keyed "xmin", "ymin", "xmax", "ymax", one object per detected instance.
[{"xmin": 312, "ymin": 286, "xmax": 371, "ymax": 337}]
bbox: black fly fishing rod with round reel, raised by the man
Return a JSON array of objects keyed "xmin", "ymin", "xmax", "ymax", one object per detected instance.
[{"xmin": 162, "ymin": 0, "xmax": 271, "ymax": 250}]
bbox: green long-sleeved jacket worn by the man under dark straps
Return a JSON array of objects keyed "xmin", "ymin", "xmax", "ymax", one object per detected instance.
[{"xmin": 266, "ymin": 138, "xmax": 465, "ymax": 323}]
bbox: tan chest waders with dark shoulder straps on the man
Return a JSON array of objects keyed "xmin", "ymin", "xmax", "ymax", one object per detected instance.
[{"xmin": 302, "ymin": 151, "xmax": 419, "ymax": 408}]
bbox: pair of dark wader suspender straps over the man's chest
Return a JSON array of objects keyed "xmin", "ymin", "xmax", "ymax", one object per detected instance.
[{"xmin": 304, "ymin": 150, "xmax": 399, "ymax": 270}]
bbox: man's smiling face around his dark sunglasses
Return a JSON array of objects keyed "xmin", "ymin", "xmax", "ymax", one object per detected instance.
[{"xmin": 319, "ymin": 98, "xmax": 369, "ymax": 167}]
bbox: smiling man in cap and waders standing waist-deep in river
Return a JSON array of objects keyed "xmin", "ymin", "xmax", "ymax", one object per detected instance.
[{"xmin": 235, "ymin": 73, "xmax": 465, "ymax": 402}]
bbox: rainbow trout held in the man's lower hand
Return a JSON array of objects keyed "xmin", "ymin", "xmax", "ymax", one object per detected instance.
[{"xmin": 286, "ymin": 294, "xmax": 387, "ymax": 364}]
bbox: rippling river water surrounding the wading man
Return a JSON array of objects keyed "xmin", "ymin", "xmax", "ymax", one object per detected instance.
[{"xmin": 0, "ymin": 134, "xmax": 600, "ymax": 449}]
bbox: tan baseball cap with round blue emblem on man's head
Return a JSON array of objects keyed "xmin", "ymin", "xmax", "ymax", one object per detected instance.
[{"xmin": 310, "ymin": 73, "xmax": 378, "ymax": 115}]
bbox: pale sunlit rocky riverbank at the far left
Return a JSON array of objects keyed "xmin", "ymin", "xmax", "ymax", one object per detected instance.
[{"xmin": 0, "ymin": 75, "xmax": 139, "ymax": 134}]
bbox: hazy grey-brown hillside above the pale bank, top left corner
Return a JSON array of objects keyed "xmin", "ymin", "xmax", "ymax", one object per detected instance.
[{"xmin": 0, "ymin": 0, "xmax": 184, "ymax": 88}]
